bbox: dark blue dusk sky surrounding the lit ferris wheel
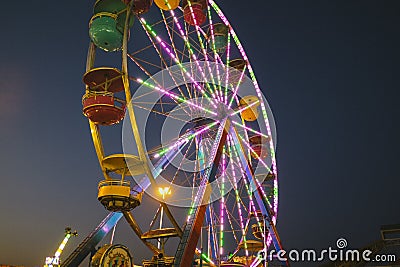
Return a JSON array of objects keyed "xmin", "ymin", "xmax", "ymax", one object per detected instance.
[{"xmin": 0, "ymin": 0, "xmax": 400, "ymax": 266}]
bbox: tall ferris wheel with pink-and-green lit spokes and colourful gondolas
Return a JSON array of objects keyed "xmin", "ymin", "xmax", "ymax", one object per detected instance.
[{"xmin": 82, "ymin": 0, "xmax": 288, "ymax": 266}]
